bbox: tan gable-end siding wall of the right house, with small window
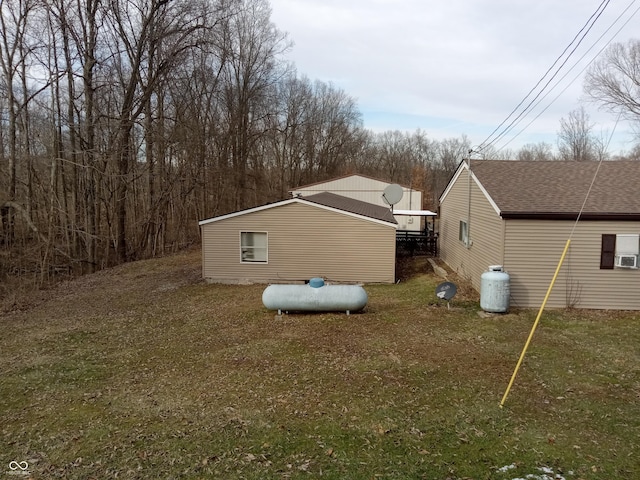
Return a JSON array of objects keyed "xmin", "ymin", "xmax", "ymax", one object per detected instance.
[{"xmin": 439, "ymin": 170, "xmax": 504, "ymax": 290}]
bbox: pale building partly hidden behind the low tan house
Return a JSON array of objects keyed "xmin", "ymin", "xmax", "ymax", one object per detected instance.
[{"xmin": 290, "ymin": 174, "xmax": 424, "ymax": 231}]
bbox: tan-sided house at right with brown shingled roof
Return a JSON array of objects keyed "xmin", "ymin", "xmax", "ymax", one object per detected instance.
[{"xmin": 439, "ymin": 160, "xmax": 640, "ymax": 310}]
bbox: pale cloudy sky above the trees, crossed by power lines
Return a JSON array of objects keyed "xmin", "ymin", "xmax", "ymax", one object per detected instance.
[{"xmin": 270, "ymin": 0, "xmax": 640, "ymax": 152}]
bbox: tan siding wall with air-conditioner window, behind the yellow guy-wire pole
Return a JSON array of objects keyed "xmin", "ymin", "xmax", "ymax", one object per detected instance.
[{"xmin": 504, "ymin": 220, "xmax": 640, "ymax": 310}]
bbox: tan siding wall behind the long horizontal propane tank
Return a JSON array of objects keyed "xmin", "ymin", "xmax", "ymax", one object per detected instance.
[{"xmin": 202, "ymin": 203, "xmax": 395, "ymax": 283}]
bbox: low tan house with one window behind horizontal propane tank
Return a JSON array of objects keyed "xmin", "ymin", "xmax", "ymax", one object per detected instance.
[{"xmin": 200, "ymin": 192, "xmax": 397, "ymax": 283}]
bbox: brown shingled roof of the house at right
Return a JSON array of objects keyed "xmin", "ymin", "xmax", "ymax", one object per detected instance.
[{"xmin": 471, "ymin": 160, "xmax": 640, "ymax": 220}]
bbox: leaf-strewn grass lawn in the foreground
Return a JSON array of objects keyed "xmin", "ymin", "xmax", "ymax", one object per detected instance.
[{"xmin": 0, "ymin": 250, "xmax": 640, "ymax": 480}]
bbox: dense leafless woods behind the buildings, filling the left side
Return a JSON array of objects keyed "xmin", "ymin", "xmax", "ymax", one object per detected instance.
[{"xmin": 0, "ymin": 0, "xmax": 468, "ymax": 281}]
